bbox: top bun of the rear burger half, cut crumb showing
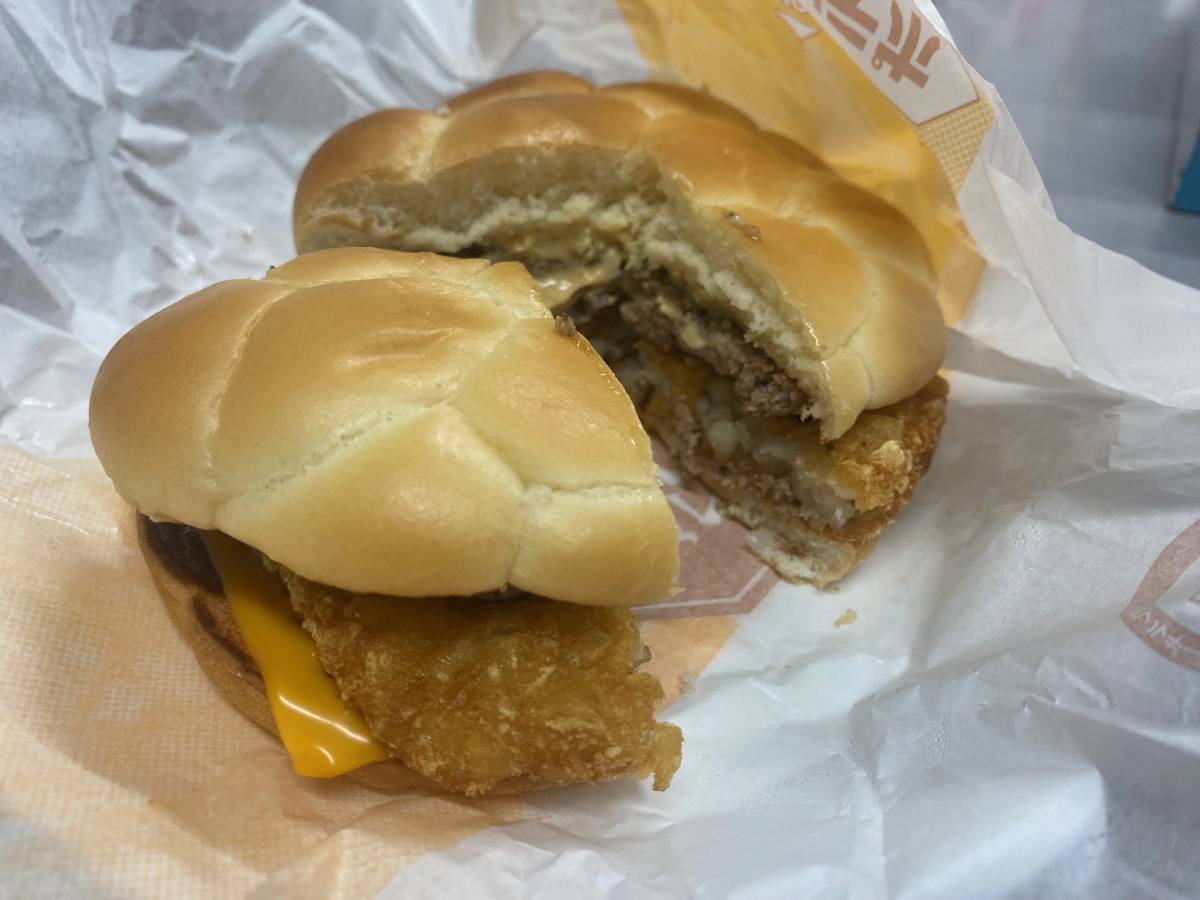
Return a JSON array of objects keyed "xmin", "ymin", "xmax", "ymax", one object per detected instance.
[{"xmin": 293, "ymin": 72, "xmax": 946, "ymax": 438}]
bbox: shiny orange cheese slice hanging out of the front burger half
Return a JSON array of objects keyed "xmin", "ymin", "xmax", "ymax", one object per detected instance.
[{"xmin": 204, "ymin": 532, "xmax": 388, "ymax": 778}]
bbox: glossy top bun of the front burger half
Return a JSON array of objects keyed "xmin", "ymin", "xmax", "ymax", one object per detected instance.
[{"xmin": 91, "ymin": 250, "xmax": 678, "ymax": 606}]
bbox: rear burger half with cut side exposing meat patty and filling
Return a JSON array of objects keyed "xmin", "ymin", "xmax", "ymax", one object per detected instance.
[{"xmin": 293, "ymin": 72, "xmax": 947, "ymax": 586}]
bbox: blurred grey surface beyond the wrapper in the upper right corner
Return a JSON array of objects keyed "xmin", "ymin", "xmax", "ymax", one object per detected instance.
[{"xmin": 935, "ymin": 0, "xmax": 1200, "ymax": 287}]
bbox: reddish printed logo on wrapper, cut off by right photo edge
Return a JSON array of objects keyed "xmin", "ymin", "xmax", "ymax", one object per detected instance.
[{"xmin": 1121, "ymin": 522, "xmax": 1200, "ymax": 672}]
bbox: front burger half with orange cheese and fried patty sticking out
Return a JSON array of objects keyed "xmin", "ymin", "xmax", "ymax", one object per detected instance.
[{"xmin": 90, "ymin": 250, "xmax": 682, "ymax": 796}]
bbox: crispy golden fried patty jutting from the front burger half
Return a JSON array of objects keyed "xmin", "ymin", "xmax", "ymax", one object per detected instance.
[{"xmin": 274, "ymin": 571, "xmax": 683, "ymax": 796}]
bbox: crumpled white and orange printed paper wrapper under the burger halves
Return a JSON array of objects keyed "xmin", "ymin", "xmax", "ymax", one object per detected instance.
[{"xmin": 0, "ymin": 0, "xmax": 1200, "ymax": 898}]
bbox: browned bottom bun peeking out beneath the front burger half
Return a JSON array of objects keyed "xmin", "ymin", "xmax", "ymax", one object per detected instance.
[{"xmin": 137, "ymin": 515, "xmax": 585, "ymax": 794}]
